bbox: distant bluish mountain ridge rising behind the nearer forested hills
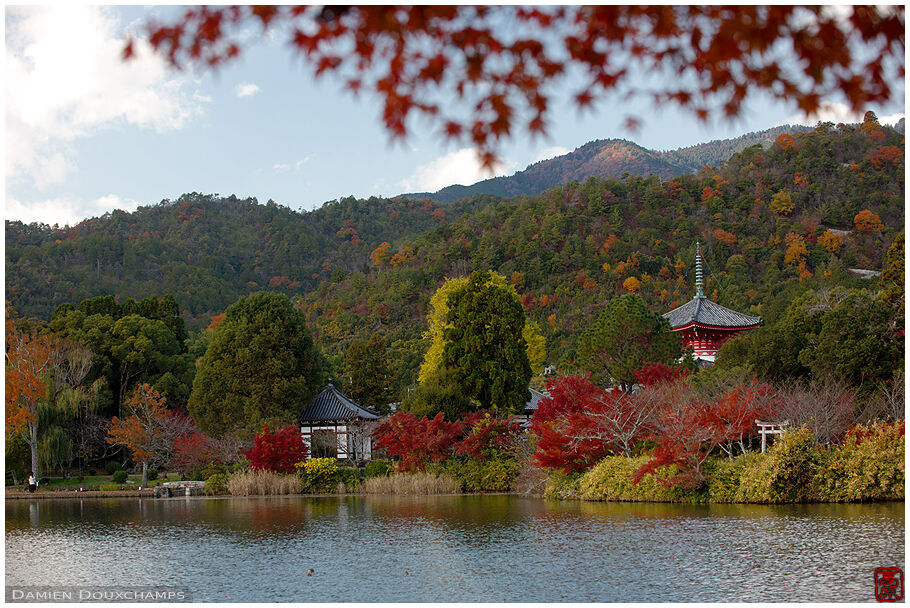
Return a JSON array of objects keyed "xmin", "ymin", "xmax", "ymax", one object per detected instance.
[{"xmin": 395, "ymin": 125, "xmax": 812, "ymax": 204}]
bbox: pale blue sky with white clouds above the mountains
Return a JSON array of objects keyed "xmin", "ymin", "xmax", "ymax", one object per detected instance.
[{"xmin": 3, "ymin": 4, "xmax": 904, "ymax": 226}]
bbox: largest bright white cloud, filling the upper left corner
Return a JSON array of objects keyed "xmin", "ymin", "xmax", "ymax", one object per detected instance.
[{"xmin": 4, "ymin": 4, "xmax": 206, "ymax": 188}]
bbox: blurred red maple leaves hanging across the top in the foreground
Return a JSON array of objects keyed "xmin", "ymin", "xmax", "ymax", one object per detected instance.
[{"xmin": 123, "ymin": 5, "xmax": 904, "ymax": 166}]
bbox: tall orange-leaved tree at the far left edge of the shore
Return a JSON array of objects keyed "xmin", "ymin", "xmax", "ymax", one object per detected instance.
[{"xmin": 6, "ymin": 309, "xmax": 53, "ymax": 479}]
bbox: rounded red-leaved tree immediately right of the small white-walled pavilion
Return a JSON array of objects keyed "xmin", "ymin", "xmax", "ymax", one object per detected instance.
[{"xmin": 373, "ymin": 412, "xmax": 465, "ymax": 471}]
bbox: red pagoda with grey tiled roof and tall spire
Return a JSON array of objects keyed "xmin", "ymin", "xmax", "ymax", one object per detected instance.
[{"xmin": 663, "ymin": 243, "xmax": 761, "ymax": 363}]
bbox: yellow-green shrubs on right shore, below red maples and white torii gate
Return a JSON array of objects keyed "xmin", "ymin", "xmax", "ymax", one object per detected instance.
[{"xmin": 545, "ymin": 423, "xmax": 905, "ymax": 503}]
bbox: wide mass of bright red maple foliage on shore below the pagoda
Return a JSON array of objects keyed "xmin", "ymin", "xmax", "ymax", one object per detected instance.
[{"xmin": 531, "ymin": 365, "xmax": 776, "ymax": 485}]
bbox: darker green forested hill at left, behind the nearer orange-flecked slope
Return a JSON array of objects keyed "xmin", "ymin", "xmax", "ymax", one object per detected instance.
[{"xmin": 6, "ymin": 193, "xmax": 485, "ymax": 327}]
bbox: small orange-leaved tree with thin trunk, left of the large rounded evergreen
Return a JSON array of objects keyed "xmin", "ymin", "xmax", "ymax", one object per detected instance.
[{"xmin": 107, "ymin": 384, "xmax": 172, "ymax": 488}]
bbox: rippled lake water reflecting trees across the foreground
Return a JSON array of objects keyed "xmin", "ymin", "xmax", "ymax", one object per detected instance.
[{"xmin": 6, "ymin": 496, "xmax": 904, "ymax": 602}]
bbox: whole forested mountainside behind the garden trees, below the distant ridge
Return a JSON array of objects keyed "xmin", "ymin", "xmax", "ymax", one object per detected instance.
[{"xmin": 6, "ymin": 121, "xmax": 904, "ymax": 396}]
